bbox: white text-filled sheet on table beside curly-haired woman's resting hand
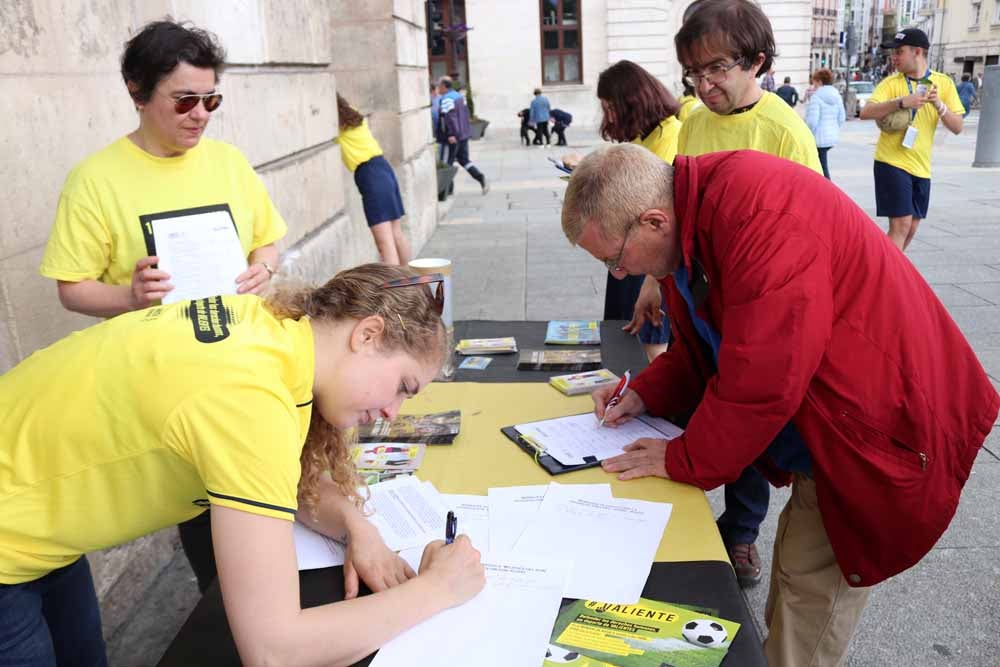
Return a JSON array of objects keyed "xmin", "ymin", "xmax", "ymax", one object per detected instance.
[{"xmin": 361, "ymin": 475, "xmax": 448, "ymax": 551}]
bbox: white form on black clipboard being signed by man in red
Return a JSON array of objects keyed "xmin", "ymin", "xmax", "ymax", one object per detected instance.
[{"xmin": 514, "ymin": 412, "xmax": 684, "ymax": 465}]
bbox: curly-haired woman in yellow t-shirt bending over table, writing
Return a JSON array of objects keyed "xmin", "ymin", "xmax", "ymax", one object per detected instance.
[{"xmin": 0, "ymin": 264, "xmax": 485, "ymax": 665}]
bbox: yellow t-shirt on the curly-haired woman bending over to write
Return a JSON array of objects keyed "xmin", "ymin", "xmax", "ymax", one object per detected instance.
[{"xmin": 0, "ymin": 295, "xmax": 315, "ymax": 584}]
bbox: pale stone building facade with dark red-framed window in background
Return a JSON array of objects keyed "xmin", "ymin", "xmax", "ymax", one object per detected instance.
[{"xmin": 429, "ymin": 0, "xmax": 813, "ymax": 128}]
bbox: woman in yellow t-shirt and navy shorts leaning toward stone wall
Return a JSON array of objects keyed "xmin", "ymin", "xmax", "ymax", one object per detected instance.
[{"xmin": 335, "ymin": 93, "xmax": 411, "ymax": 265}]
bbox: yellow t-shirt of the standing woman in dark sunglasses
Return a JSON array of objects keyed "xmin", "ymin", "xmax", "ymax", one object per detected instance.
[{"xmin": 40, "ymin": 137, "xmax": 287, "ymax": 285}]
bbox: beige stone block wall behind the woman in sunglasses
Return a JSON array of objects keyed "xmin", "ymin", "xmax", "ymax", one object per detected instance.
[{"xmin": 0, "ymin": 0, "xmax": 437, "ymax": 635}]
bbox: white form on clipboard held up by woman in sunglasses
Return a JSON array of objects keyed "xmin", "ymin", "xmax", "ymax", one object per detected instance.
[{"xmin": 151, "ymin": 210, "xmax": 247, "ymax": 304}]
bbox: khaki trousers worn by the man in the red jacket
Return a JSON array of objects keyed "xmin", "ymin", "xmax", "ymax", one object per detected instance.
[{"xmin": 764, "ymin": 475, "xmax": 871, "ymax": 667}]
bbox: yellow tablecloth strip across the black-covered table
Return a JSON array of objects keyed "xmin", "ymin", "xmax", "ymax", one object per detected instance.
[{"xmin": 403, "ymin": 382, "xmax": 729, "ymax": 562}]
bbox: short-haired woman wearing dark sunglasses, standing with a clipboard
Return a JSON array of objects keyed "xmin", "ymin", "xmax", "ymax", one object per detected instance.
[{"xmin": 41, "ymin": 20, "xmax": 286, "ymax": 317}]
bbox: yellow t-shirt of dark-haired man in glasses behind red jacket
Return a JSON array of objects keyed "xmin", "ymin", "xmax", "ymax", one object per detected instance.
[{"xmin": 677, "ymin": 93, "xmax": 823, "ymax": 174}]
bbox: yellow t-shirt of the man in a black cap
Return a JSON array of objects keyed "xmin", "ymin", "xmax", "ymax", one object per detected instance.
[{"xmin": 869, "ymin": 71, "xmax": 965, "ymax": 178}]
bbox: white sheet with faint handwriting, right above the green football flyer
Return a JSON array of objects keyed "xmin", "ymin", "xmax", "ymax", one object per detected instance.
[{"xmin": 514, "ymin": 484, "xmax": 671, "ymax": 604}]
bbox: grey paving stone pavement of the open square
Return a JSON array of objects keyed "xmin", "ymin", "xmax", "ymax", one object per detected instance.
[{"xmin": 109, "ymin": 114, "xmax": 1000, "ymax": 667}]
